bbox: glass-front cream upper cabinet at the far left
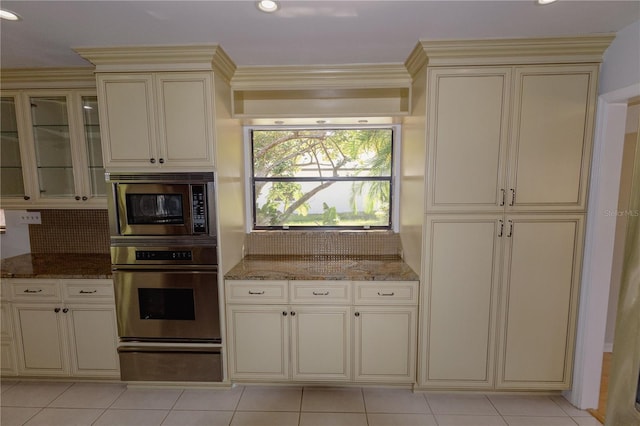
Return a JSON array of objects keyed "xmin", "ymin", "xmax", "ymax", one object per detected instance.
[{"xmin": 0, "ymin": 71, "xmax": 106, "ymax": 208}]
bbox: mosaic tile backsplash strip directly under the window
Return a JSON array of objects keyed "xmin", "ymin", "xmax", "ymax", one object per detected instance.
[{"xmin": 245, "ymin": 231, "xmax": 402, "ymax": 256}]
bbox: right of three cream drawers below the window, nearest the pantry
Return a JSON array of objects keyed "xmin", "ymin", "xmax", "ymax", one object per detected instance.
[{"xmin": 354, "ymin": 281, "xmax": 418, "ymax": 305}]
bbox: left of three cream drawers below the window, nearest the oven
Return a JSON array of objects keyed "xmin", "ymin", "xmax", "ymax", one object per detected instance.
[{"xmin": 225, "ymin": 280, "xmax": 289, "ymax": 304}]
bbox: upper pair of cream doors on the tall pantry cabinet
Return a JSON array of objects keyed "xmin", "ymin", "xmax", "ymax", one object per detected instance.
[{"xmin": 426, "ymin": 64, "xmax": 598, "ymax": 213}]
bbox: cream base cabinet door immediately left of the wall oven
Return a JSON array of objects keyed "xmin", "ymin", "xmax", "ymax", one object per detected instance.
[{"xmin": 66, "ymin": 305, "xmax": 120, "ymax": 377}]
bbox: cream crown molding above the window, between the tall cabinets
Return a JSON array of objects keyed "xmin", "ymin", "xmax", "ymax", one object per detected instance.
[{"xmin": 231, "ymin": 64, "xmax": 411, "ymax": 90}]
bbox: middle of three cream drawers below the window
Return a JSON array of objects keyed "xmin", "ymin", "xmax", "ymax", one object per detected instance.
[{"xmin": 289, "ymin": 281, "xmax": 351, "ymax": 305}]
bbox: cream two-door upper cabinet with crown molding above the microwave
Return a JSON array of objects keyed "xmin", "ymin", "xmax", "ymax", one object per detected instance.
[{"xmin": 77, "ymin": 45, "xmax": 235, "ymax": 172}]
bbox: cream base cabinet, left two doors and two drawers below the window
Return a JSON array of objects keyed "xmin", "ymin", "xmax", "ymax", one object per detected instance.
[{"xmin": 226, "ymin": 280, "xmax": 351, "ymax": 381}]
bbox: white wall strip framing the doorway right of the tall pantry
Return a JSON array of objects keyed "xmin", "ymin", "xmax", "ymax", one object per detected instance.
[{"xmin": 566, "ymin": 21, "xmax": 640, "ymax": 409}]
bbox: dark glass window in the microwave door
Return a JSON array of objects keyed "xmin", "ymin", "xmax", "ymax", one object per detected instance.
[{"xmin": 126, "ymin": 194, "xmax": 185, "ymax": 225}]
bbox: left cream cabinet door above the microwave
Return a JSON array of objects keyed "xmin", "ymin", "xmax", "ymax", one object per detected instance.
[{"xmin": 97, "ymin": 74, "xmax": 157, "ymax": 169}]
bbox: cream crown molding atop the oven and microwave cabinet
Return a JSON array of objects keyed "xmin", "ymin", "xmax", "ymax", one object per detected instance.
[{"xmin": 73, "ymin": 44, "xmax": 236, "ymax": 82}]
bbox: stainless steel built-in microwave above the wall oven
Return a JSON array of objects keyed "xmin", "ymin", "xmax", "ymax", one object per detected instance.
[{"xmin": 106, "ymin": 173, "xmax": 215, "ymax": 237}]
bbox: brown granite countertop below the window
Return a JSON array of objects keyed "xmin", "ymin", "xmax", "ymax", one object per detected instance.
[{"xmin": 224, "ymin": 255, "xmax": 418, "ymax": 281}]
